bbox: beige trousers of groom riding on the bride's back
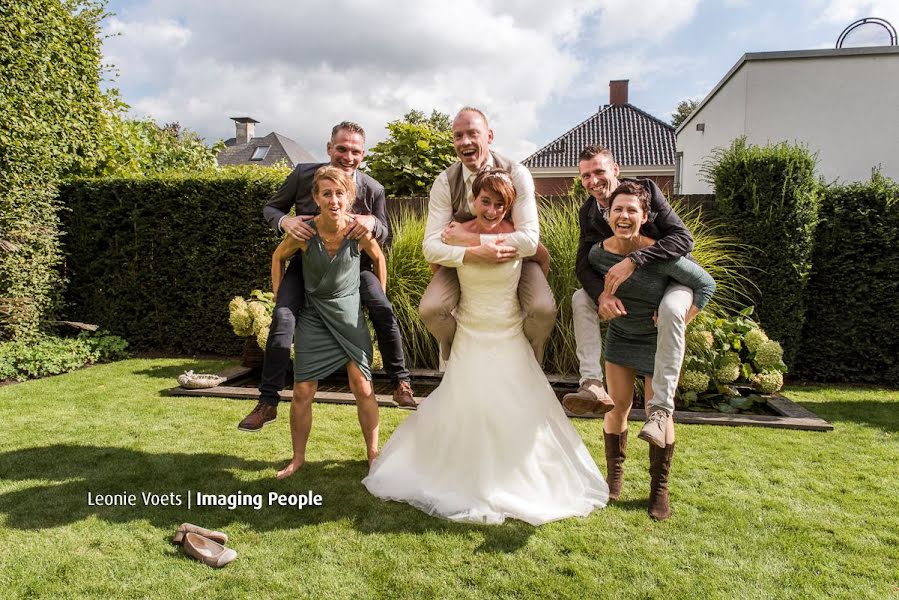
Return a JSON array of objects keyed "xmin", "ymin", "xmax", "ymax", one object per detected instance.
[{"xmin": 418, "ymin": 260, "xmax": 556, "ymax": 364}]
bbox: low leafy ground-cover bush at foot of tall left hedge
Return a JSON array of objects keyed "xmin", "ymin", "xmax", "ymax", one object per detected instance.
[{"xmin": 0, "ymin": 332, "xmax": 128, "ymax": 381}]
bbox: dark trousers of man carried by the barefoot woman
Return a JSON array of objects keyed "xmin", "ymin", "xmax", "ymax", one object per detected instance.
[{"xmin": 253, "ymin": 254, "xmax": 409, "ymax": 405}]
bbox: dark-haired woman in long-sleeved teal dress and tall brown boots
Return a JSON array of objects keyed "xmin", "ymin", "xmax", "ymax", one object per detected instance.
[{"xmin": 590, "ymin": 182, "xmax": 715, "ymax": 520}]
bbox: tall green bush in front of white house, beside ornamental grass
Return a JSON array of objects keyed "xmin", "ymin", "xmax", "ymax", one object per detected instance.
[{"xmin": 703, "ymin": 138, "xmax": 818, "ymax": 364}]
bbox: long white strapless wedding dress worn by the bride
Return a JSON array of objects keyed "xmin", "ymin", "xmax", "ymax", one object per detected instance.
[{"xmin": 362, "ymin": 260, "xmax": 609, "ymax": 525}]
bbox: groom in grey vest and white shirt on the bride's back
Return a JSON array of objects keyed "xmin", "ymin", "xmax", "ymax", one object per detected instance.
[{"xmin": 418, "ymin": 106, "xmax": 556, "ymax": 364}]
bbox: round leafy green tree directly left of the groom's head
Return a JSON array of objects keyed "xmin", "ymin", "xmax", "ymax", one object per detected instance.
[{"xmin": 366, "ymin": 110, "xmax": 456, "ymax": 196}]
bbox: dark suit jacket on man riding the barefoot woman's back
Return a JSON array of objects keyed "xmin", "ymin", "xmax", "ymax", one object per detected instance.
[{"xmin": 262, "ymin": 163, "xmax": 390, "ymax": 246}]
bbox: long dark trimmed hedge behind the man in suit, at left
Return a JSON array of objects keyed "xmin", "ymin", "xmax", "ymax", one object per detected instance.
[{"xmin": 60, "ymin": 168, "xmax": 286, "ymax": 354}]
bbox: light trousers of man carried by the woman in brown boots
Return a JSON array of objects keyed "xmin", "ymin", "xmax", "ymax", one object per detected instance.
[{"xmin": 571, "ymin": 284, "xmax": 693, "ymax": 414}]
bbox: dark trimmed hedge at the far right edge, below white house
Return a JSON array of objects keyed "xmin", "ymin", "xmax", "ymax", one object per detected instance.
[{"xmin": 797, "ymin": 175, "xmax": 899, "ymax": 385}]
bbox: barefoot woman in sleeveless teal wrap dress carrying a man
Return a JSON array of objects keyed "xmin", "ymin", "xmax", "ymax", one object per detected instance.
[{"xmin": 272, "ymin": 166, "xmax": 387, "ymax": 479}]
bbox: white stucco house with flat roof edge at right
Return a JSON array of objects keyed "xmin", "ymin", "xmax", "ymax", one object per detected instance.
[{"xmin": 674, "ymin": 46, "xmax": 899, "ymax": 194}]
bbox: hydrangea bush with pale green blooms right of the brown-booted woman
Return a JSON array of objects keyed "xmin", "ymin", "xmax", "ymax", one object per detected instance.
[{"xmin": 678, "ymin": 307, "xmax": 787, "ymax": 413}]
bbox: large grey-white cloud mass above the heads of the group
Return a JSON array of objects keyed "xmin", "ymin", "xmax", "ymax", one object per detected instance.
[{"xmin": 104, "ymin": 0, "xmax": 698, "ymax": 158}]
